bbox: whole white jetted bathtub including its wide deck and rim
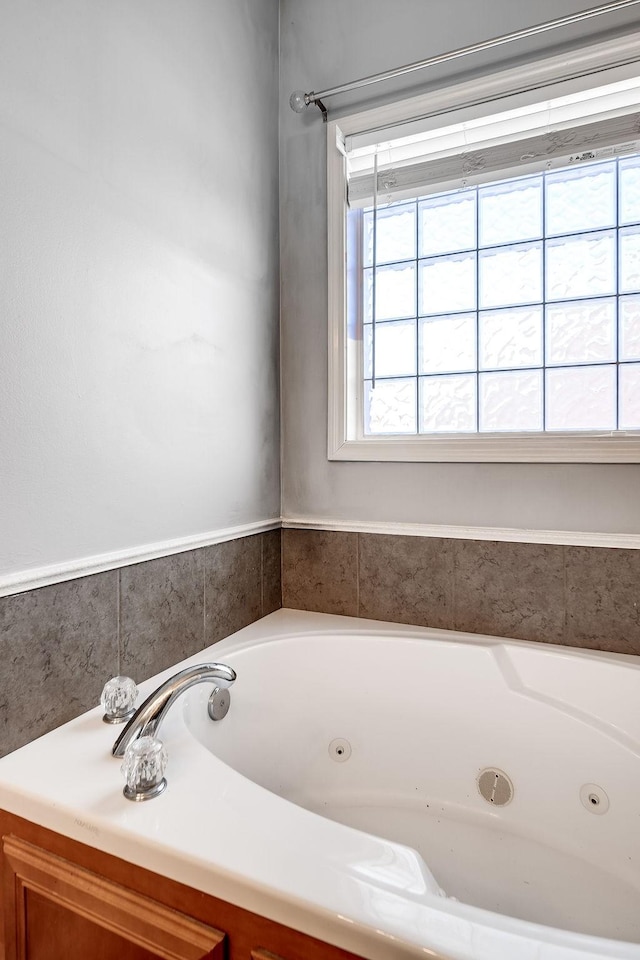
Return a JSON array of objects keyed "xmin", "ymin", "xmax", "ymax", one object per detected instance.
[{"xmin": 0, "ymin": 610, "xmax": 640, "ymax": 960}]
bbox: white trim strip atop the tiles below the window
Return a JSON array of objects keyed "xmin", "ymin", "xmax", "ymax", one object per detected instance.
[{"xmin": 282, "ymin": 517, "xmax": 640, "ymax": 550}]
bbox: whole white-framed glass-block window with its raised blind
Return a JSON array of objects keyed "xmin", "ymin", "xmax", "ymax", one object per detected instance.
[{"xmin": 329, "ymin": 35, "xmax": 640, "ymax": 462}]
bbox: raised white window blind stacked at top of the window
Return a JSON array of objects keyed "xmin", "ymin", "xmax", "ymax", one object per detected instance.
[{"xmin": 346, "ymin": 79, "xmax": 640, "ymax": 207}]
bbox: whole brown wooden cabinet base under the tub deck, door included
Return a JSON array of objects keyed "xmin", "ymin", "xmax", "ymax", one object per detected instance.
[{"xmin": 0, "ymin": 811, "xmax": 358, "ymax": 960}]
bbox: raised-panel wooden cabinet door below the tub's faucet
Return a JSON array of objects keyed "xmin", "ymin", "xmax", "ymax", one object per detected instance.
[{"xmin": 3, "ymin": 836, "xmax": 225, "ymax": 960}]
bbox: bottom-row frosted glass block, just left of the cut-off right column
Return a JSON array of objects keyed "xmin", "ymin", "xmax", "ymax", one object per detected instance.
[{"xmin": 546, "ymin": 366, "xmax": 616, "ymax": 430}]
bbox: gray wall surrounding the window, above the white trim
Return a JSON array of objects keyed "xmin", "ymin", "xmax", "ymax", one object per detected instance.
[{"xmin": 280, "ymin": 0, "xmax": 640, "ymax": 533}]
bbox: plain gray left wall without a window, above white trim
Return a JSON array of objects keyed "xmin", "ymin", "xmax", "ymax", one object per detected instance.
[{"xmin": 0, "ymin": 0, "xmax": 280, "ymax": 585}]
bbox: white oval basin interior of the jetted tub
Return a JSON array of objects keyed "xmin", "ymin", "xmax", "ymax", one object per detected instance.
[{"xmin": 184, "ymin": 635, "xmax": 640, "ymax": 942}]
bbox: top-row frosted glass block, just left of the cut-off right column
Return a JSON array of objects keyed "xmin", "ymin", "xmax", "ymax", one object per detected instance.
[{"xmin": 545, "ymin": 163, "xmax": 616, "ymax": 235}]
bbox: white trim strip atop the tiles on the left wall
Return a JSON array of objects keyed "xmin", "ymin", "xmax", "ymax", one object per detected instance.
[{"xmin": 0, "ymin": 517, "xmax": 281, "ymax": 597}]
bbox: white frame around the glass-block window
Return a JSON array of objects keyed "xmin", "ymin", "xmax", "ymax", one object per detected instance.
[{"xmin": 327, "ymin": 33, "xmax": 640, "ymax": 463}]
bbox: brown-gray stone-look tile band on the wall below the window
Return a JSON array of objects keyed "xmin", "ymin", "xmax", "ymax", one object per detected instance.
[{"xmin": 282, "ymin": 530, "xmax": 640, "ymax": 655}]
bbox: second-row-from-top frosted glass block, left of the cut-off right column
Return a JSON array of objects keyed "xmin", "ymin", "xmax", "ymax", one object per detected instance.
[{"xmin": 547, "ymin": 231, "xmax": 616, "ymax": 300}]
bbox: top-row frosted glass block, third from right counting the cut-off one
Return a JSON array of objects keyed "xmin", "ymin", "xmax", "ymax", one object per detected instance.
[{"xmin": 478, "ymin": 177, "xmax": 542, "ymax": 247}]
